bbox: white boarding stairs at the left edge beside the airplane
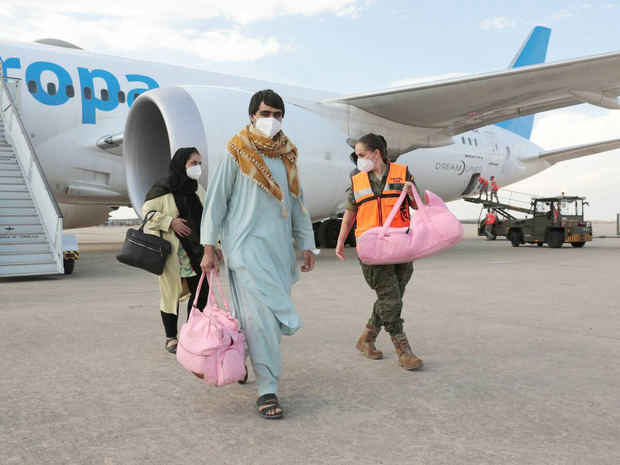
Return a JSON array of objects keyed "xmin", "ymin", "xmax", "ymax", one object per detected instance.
[{"xmin": 0, "ymin": 73, "xmax": 63, "ymax": 278}]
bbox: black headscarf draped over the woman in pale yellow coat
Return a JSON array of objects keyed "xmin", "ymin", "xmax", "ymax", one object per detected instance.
[{"xmin": 144, "ymin": 147, "xmax": 203, "ymax": 274}]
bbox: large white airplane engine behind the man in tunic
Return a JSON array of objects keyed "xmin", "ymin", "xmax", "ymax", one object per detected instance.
[{"xmin": 123, "ymin": 86, "xmax": 354, "ymax": 219}]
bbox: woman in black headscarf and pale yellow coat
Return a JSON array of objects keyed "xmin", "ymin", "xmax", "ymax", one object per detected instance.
[{"xmin": 142, "ymin": 147, "xmax": 209, "ymax": 353}]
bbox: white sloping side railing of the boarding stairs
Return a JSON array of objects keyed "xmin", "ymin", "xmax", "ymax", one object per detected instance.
[{"xmin": 0, "ymin": 69, "xmax": 63, "ymax": 272}]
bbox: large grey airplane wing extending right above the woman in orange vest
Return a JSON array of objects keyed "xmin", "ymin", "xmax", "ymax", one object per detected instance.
[{"xmin": 322, "ymin": 52, "xmax": 620, "ymax": 148}]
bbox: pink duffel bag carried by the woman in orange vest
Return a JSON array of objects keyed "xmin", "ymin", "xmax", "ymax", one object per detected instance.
[{"xmin": 357, "ymin": 187, "xmax": 463, "ymax": 265}]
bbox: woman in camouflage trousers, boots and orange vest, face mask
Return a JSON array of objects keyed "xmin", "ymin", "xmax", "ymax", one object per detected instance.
[{"xmin": 336, "ymin": 134, "xmax": 423, "ymax": 370}]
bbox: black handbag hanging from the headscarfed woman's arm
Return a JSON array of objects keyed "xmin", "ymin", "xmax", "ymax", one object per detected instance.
[{"xmin": 116, "ymin": 210, "xmax": 172, "ymax": 275}]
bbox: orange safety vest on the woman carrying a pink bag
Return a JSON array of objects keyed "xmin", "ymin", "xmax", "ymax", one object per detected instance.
[{"xmin": 352, "ymin": 163, "xmax": 409, "ymax": 238}]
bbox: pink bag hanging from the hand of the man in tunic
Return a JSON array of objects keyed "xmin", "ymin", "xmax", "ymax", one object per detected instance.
[{"xmin": 177, "ymin": 272, "xmax": 246, "ymax": 386}]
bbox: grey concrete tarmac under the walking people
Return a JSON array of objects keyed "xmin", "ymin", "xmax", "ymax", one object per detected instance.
[{"xmin": 0, "ymin": 224, "xmax": 620, "ymax": 465}]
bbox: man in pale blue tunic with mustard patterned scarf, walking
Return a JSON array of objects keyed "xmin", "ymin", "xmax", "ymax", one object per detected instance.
[{"xmin": 200, "ymin": 90, "xmax": 315, "ymax": 418}]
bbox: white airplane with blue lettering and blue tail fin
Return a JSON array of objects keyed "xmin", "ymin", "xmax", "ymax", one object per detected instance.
[{"xmin": 0, "ymin": 26, "xmax": 620, "ymax": 275}]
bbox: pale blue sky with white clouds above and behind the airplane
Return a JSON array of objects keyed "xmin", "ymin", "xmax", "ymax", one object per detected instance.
[{"xmin": 0, "ymin": 0, "xmax": 620, "ymax": 220}]
